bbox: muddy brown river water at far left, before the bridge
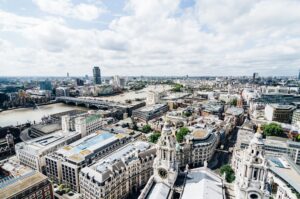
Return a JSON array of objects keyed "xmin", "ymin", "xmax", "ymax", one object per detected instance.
[{"xmin": 0, "ymin": 103, "xmax": 88, "ymax": 127}]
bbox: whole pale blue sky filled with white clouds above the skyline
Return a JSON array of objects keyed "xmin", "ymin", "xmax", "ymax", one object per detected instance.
[{"xmin": 0, "ymin": 0, "xmax": 300, "ymax": 76}]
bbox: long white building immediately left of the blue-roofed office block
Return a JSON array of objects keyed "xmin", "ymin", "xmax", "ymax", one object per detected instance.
[{"xmin": 15, "ymin": 131, "xmax": 81, "ymax": 172}]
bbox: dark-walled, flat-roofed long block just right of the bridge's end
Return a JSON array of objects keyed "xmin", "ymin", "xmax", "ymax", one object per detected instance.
[{"xmin": 132, "ymin": 104, "xmax": 168, "ymax": 122}]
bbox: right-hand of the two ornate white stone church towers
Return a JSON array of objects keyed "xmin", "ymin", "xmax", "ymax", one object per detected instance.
[{"xmin": 232, "ymin": 132, "xmax": 271, "ymax": 199}]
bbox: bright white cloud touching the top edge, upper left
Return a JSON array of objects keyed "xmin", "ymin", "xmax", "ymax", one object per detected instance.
[{"xmin": 33, "ymin": 0, "xmax": 105, "ymax": 21}]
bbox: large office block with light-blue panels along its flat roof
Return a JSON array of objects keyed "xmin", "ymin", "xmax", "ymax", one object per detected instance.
[{"xmin": 45, "ymin": 131, "xmax": 131, "ymax": 192}]
